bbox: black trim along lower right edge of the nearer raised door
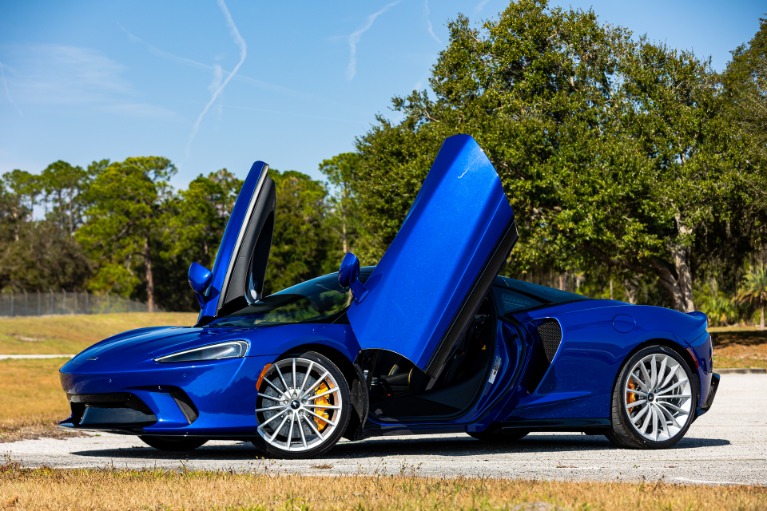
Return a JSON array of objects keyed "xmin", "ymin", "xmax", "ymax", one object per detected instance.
[{"xmin": 424, "ymin": 217, "xmax": 519, "ymax": 380}]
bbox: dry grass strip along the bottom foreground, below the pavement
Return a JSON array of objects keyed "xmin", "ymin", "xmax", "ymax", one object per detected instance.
[{"xmin": 0, "ymin": 468, "xmax": 767, "ymax": 510}]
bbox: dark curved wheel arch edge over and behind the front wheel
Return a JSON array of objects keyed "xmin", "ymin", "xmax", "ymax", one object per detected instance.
[{"xmin": 275, "ymin": 342, "xmax": 368, "ymax": 440}]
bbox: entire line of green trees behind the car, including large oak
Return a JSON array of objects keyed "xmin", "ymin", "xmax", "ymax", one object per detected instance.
[{"xmin": 0, "ymin": 0, "xmax": 767, "ymax": 323}]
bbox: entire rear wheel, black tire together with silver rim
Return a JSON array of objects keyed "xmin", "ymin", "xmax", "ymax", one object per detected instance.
[{"xmin": 607, "ymin": 345, "xmax": 698, "ymax": 449}]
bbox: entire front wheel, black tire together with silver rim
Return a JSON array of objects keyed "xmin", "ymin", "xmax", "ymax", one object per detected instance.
[{"xmin": 253, "ymin": 351, "xmax": 352, "ymax": 459}]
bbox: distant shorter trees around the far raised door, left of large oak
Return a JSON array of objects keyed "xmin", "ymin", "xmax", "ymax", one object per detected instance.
[{"xmin": 0, "ymin": 157, "xmax": 343, "ymax": 310}]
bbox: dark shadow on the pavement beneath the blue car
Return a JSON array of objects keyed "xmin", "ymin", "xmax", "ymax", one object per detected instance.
[{"xmin": 67, "ymin": 434, "xmax": 730, "ymax": 460}]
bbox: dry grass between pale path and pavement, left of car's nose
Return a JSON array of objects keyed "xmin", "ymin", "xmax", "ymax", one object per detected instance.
[{"xmin": 0, "ymin": 359, "xmax": 69, "ymax": 442}]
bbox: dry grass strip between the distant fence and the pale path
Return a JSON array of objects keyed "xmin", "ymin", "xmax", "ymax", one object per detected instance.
[{"xmin": 0, "ymin": 312, "xmax": 197, "ymax": 355}]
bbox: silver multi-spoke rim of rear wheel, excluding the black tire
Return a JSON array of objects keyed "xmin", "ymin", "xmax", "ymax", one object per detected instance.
[{"xmin": 623, "ymin": 353, "xmax": 693, "ymax": 442}]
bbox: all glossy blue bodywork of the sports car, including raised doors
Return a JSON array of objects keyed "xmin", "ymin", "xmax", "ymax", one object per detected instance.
[{"xmin": 61, "ymin": 136, "xmax": 716, "ymax": 454}]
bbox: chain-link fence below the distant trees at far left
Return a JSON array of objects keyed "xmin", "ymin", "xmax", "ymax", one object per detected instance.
[{"xmin": 0, "ymin": 291, "xmax": 152, "ymax": 316}]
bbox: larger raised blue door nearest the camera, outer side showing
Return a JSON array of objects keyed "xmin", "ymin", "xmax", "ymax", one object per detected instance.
[{"xmin": 348, "ymin": 135, "xmax": 517, "ymax": 379}]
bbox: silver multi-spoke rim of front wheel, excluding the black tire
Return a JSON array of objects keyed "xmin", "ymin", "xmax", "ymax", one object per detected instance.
[{"xmin": 256, "ymin": 358, "xmax": 344, "ymax": 452}]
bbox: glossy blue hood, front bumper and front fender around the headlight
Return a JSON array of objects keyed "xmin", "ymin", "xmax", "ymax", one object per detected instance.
[{"xmin": 60, "ymin": 324, "xmax": 359, "ymax": 436}]
